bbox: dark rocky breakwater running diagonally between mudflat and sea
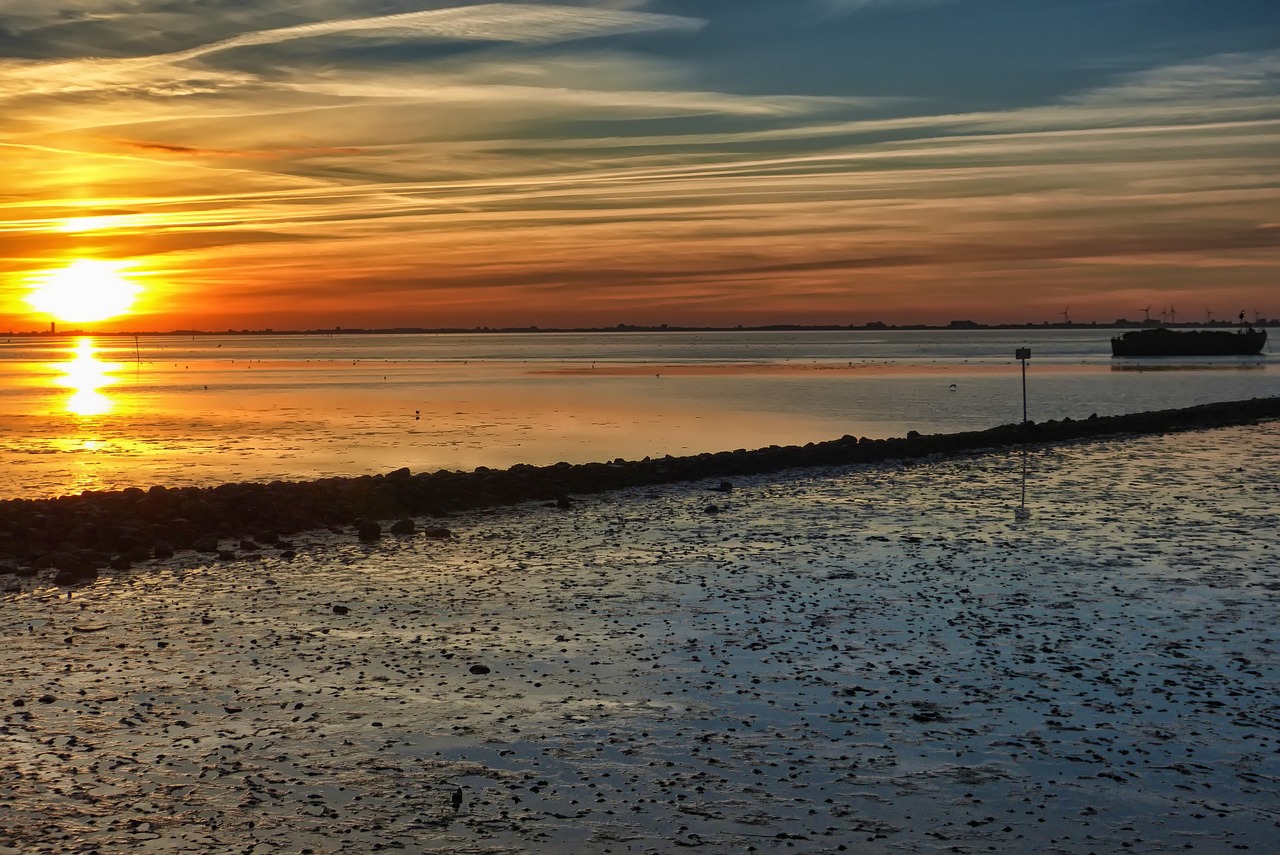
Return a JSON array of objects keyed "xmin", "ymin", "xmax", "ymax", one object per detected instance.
[{"xmin": 0, "ymin": 398, "xmax": 1280, "ymax": 590}]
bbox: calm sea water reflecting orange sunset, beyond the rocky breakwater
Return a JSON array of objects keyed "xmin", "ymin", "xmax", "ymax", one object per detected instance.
[{"xmin": 0, "ymin": 329, "xmax": 1280, "ymax": 497}]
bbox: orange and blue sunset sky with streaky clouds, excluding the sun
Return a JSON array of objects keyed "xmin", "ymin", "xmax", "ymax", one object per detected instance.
[{"xmin": 0, "ymin": 0, "xmax": 1280, "ymax": 330}]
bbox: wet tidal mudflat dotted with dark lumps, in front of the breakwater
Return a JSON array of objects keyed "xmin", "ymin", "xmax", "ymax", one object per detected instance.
[{"xmin": 0, "ymin": 424, "xmax": 1280, "ymax": 855}]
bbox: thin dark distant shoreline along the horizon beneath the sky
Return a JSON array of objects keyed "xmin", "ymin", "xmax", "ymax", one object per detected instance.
[{"xmin": 3, "ymin": 317, "xmax": 1280, "ymax": 338}]
